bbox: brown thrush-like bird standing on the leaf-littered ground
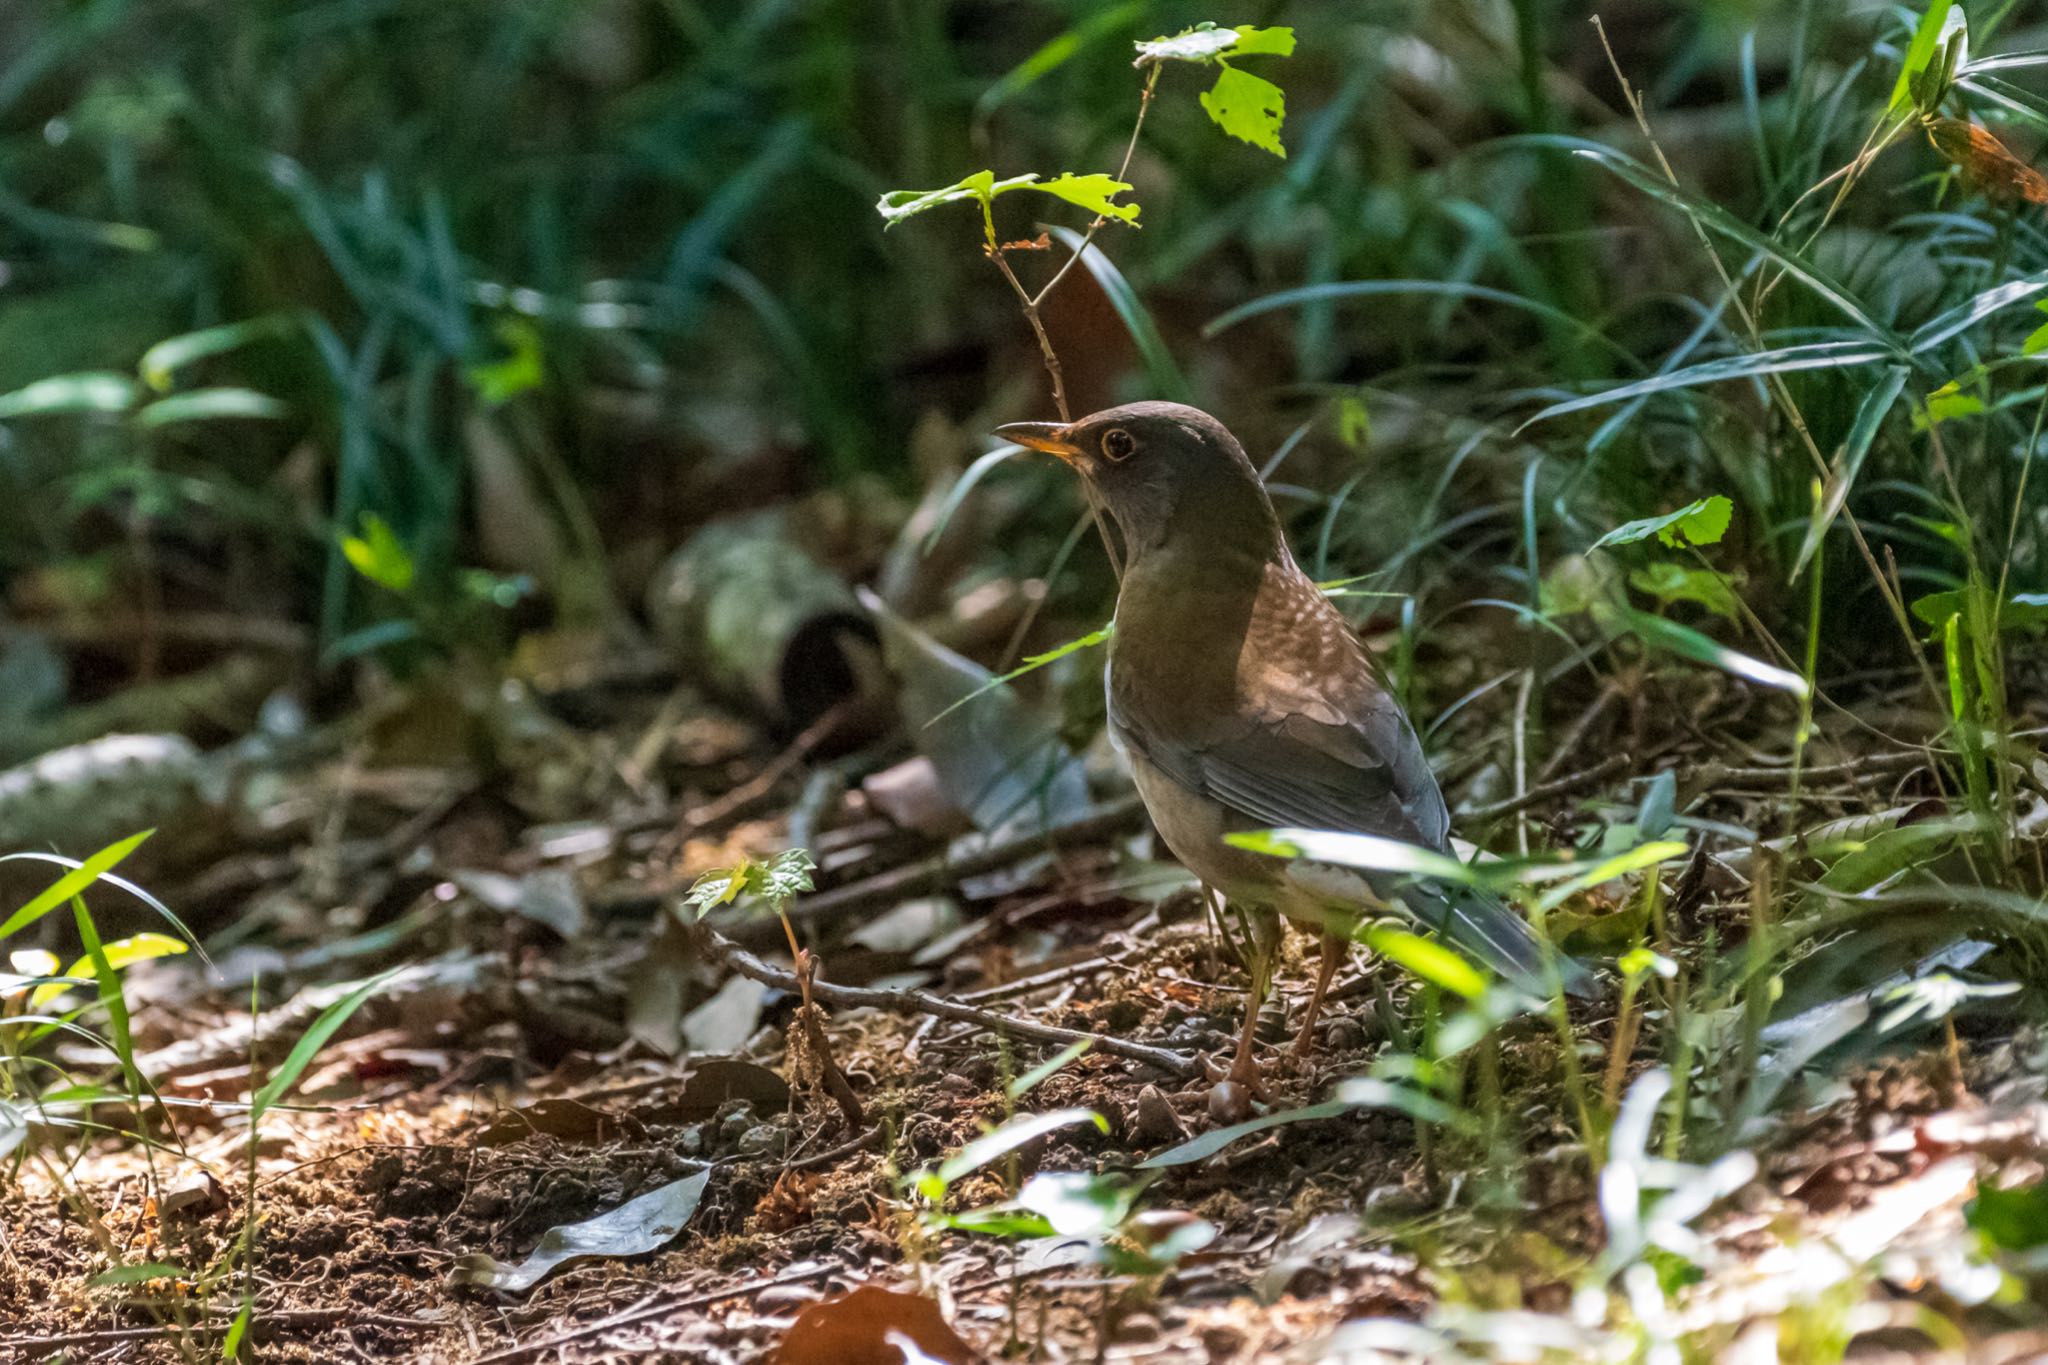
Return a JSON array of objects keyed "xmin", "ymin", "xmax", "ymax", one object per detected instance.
[{"xmin": 995, "ymin": 401, "xmax": 1587, "ymax": 1115}]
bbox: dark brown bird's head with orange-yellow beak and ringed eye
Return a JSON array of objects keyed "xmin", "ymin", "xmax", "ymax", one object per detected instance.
[{"xmin": 995, "ymin": 403, "xmax": 1280, "ymax": 561}]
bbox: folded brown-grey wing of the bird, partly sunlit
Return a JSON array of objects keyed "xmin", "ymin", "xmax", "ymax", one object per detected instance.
[{"xmin": 1110, "ymin": 565, "xmax": 1450, "ymax": 849}]
